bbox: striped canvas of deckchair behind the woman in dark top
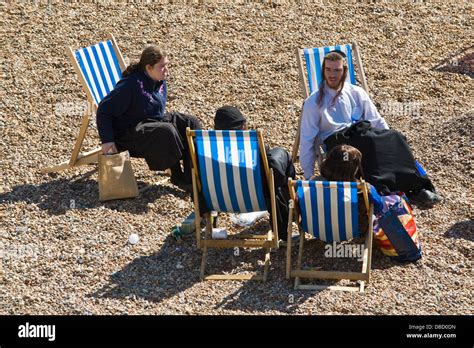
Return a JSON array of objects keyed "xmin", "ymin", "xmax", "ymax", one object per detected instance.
[{"xmin": 74, "ymin": 40, "xmax": 122, "ymax": 104}]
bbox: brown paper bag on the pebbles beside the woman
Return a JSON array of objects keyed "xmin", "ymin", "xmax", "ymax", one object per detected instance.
[{"xmin": 99, "ymin": 151, "xmax": 138, "ymax": 201}]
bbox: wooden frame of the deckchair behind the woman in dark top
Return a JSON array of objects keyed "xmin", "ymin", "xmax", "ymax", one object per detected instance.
[{"xmin": 41, "ymin": 34, "xmax": 125, "ymax": 173}]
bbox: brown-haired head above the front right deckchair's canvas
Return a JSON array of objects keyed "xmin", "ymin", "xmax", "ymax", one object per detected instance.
[{"xmin": 321, "ymin": 145, "xmax": 363, "ymax": 181}]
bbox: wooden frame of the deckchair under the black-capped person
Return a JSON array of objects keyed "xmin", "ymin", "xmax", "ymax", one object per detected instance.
[{"xmin": 186, "ymin": 128, "xmax": 278, "ymax": 282}]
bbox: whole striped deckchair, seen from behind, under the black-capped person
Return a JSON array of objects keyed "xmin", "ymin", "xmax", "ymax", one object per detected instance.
[{"xmin": 187, "ymin": 128, "xmax": 278, "ymax": 280}]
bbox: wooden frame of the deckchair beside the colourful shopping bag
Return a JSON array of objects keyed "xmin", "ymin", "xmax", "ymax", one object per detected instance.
[{"xmin": 286, "ymin": 179, "xmax": 374, "ymax": 292}]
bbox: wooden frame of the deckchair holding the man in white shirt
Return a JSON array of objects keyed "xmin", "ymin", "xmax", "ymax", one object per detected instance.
[{"xmin": 291, "ymin": 41, "xmax": 369, "ymax": 163}]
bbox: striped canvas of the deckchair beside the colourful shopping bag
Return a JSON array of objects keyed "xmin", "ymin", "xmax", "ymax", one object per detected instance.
[{"xmin": 296, "ymin": 180, "xmax": 360, "ymax": 242}]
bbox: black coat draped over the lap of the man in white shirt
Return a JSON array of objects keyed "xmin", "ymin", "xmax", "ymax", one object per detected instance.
[{"xmin": 325, "ymin": 121, "xmax": 435, "ymax": 194}]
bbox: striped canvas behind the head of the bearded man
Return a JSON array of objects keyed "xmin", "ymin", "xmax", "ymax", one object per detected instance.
[{"xmin": 303, "ymin": 44, "xmax": 356, "ymax": 94}]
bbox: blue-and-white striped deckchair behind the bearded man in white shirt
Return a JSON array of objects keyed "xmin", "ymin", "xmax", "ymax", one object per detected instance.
[{"xmin": 291, "ymin": 42, "xmax": 369, "ymax": 162}]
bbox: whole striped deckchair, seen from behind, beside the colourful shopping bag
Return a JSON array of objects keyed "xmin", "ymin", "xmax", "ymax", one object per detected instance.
[{"xmin": 287, "ymin": 180, "xmax": 373, "ymax": 291}]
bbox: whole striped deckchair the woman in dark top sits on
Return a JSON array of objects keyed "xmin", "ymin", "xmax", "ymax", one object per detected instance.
[{"xmin": 41, "ymin": 34, "xmax": 125, "ymax": 173}]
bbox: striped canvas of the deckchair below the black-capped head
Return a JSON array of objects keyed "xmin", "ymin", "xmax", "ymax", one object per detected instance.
[{"xmin": 195, "ymin": 130, "xmax": 267, "ymax": 213}]
